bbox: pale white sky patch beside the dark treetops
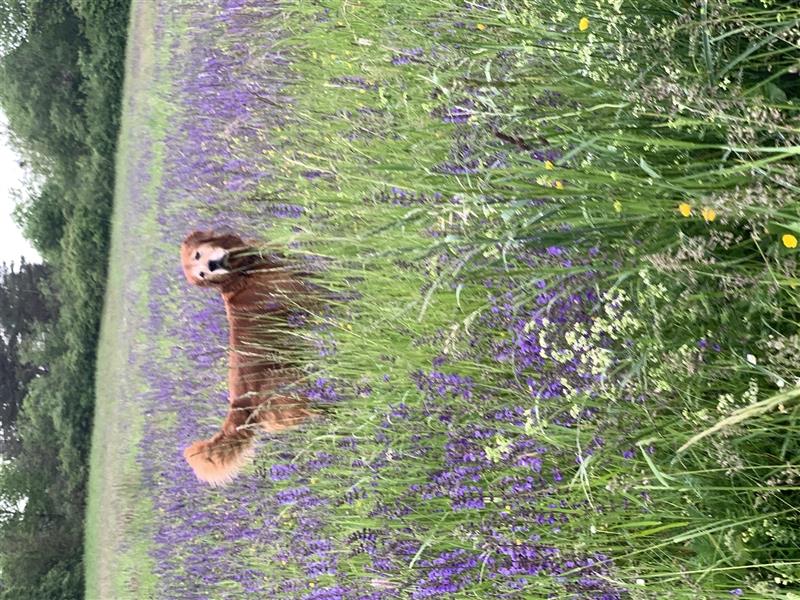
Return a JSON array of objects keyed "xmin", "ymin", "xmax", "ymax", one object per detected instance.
[{"xmin": 0, "ymin": 113, "xmax": 42, "ymax": 264}]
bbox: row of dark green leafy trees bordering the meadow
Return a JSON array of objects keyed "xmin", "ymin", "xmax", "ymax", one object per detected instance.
[{"xmin": 0, "ymin": 0, "xmax": 129, "ymax": 600}]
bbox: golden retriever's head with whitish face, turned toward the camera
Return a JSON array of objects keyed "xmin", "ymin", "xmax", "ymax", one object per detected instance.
[{"xmin": 181, "ymin": 231, "xmax": 247, "ymax": 286}]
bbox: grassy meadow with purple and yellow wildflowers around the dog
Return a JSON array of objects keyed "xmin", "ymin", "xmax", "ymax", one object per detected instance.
[{"xmin": 85, "ymin": 0, "xmax": 800, "ymax": 600}]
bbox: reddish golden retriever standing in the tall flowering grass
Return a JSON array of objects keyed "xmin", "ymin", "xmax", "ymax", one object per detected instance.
[{"xmin": 181, "ymin": 231, "xmax": 314, "ymax": 486}]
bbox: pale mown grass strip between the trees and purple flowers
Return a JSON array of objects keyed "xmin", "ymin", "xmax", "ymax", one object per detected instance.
[{"xmin": 85, "ymin": 3, "xmax": 163, "ymax": 598}]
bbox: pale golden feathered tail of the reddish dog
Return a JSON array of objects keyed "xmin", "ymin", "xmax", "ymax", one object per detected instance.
[{"xmin": 183, "ymin": 411, "xmax": 255, "ymax": 486}]
